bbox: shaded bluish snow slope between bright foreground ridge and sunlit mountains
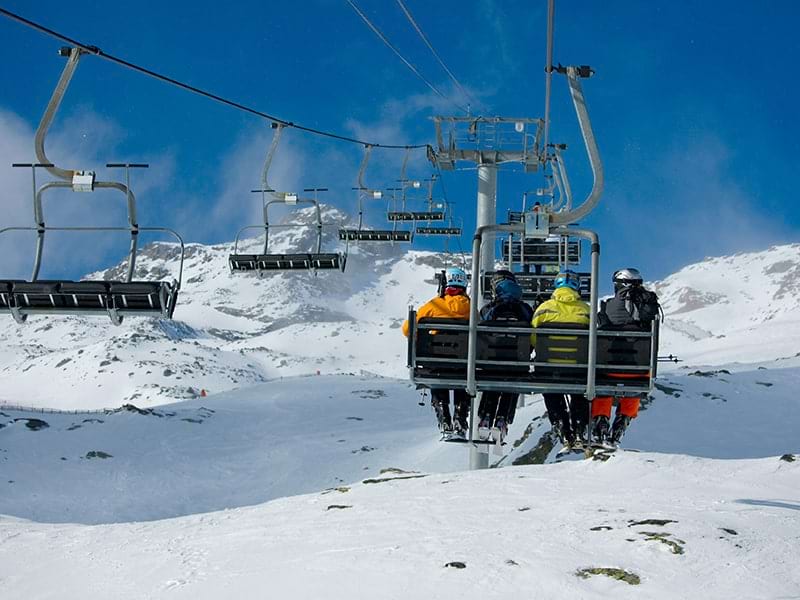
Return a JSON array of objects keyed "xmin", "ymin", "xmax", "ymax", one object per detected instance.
[{"xmin": 0, "ymin": 369, "xmax": 800, "ymax": 523}]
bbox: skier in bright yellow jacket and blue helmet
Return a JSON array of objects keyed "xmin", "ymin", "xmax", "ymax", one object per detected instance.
[{"xmin": 531, "ymin": 269, "xmax": 590, "ymax": 448}]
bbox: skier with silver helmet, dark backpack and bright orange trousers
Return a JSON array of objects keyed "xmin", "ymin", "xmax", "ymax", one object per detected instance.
[{"xmin": 592, "ymin": 268, "xmax": 660, "ymax": 445}]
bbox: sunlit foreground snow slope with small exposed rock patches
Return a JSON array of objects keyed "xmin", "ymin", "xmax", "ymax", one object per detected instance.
[{"xmin": 0, "ymin": 453, "xmax": 800, "ymax": 600}]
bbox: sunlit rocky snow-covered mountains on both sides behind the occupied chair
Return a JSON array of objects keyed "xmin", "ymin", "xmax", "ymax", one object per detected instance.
[{"xmin": 0, "ymin": 214, "xmax": 800, "ymax": 408}]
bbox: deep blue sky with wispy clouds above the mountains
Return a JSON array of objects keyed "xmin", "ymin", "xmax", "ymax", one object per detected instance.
[{"xmin": 0, "ymin": 0, "xmax": 800, "ymax": 288}]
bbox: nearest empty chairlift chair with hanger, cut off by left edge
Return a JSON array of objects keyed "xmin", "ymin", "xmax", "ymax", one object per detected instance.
[{"xmin": 0, "ymin": 48, "xmax": 184, "ymax": 325}]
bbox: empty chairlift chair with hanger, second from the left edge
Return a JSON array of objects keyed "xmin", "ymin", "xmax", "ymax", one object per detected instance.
[{"xmin": 228, "ymin": 123, "xmax": 347, "ymax": 277}]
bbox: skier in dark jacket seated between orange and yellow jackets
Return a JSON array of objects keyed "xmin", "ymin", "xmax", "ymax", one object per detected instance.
[{"xmin": 478, "ymin": 270, "xmax": 533, "ymax": 440}]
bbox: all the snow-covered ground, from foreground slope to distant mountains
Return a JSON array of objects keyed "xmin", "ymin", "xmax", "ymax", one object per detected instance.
[{"xmin": 0, "ymin": 238, "xmax": 800, "ymax": 600}]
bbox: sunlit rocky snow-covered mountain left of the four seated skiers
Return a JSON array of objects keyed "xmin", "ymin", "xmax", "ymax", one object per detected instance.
[{"xmin": 0, "ymin": 208, "xmax": 454, "ymax": 408}]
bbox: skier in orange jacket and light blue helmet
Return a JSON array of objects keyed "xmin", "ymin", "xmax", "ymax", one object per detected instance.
[{"xmin": 403, "ymin": 267, "xmax": 470, "ymax": 437}]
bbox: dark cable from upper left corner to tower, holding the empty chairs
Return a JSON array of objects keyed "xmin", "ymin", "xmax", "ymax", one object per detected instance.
[{"xmin": 0, "ymin": 7, "xmax": 429, "ymax": 150}]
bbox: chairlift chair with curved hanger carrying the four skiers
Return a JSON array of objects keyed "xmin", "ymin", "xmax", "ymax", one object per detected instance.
[{"xmin": 408, "ymin": 66, "xmax": 636, "ymax": 438}]
